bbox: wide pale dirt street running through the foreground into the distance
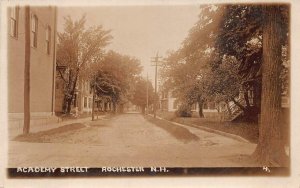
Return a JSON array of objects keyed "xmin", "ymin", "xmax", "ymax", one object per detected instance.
[{"xmin": 8, "ymin": 113, "xmax": 256, "ymax": 167}]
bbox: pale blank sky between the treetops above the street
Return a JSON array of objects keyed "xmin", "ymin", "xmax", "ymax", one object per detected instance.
[{"xmin": 58, "ymin": 5, "xmax": 200, "ymax": 81}]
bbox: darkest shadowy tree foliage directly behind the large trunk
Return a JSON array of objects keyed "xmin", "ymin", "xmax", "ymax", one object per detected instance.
[{"xmin": 211, "ymin": 5, "xmax": 289, "ymax": 120}]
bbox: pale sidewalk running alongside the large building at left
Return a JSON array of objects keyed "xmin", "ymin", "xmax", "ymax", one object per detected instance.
[{"xmin": 8, "ymin": 115, "xmax": 106, "ymax": 140}]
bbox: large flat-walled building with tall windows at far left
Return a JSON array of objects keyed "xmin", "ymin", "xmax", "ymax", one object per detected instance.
[{"xmin": 7, "ymin": 6, "xmax": 57, "ymax": 126}]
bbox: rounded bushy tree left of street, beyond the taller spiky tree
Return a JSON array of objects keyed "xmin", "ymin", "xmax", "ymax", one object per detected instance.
[{"xmin": 91, "ymin": 51, "xmax": 142, "ymax": 113}]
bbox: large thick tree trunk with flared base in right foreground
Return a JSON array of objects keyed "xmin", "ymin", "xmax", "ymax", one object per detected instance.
[{"xmin": 254, "ymin": 5, "xmax": 286, "ymax": 166}]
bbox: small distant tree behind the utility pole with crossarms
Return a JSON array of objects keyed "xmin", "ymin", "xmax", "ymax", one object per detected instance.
[{"xmin": 131, "ymin": 77, "xmax": 155, "ymax": 114}]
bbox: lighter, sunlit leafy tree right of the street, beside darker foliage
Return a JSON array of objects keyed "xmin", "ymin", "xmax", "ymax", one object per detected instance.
[{"xmin": 162, "ymin": 5, "xmax": 223, "ymax": 117}]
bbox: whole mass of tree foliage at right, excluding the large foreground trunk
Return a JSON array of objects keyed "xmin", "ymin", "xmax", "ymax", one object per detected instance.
[{"xmin": 163, "ymin": 4, "xmax": 289, "ymax": 121}]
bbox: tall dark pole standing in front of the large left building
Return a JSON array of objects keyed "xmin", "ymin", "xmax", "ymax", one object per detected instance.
[{"xmin": 23, "ymin": 6, "xmax": 30, "ymax": 134}]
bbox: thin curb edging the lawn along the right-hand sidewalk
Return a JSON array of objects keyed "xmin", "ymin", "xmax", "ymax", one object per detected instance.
[{"xmin": 149, "ymin": 116, "xmax": 251, "ymax": 143}]
